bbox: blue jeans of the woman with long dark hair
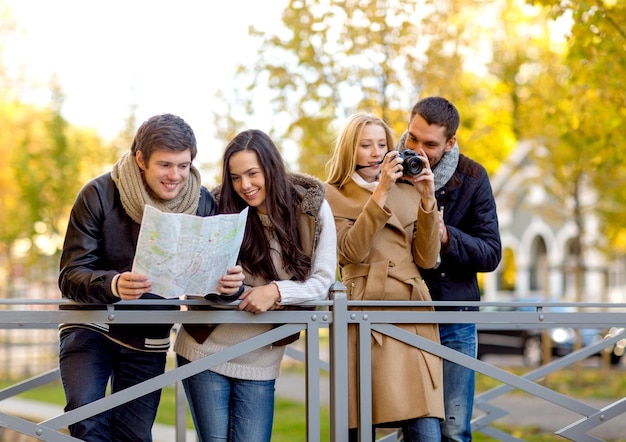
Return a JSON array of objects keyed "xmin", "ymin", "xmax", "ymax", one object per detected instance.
[{"xmin": 177, "ymin": 355, "xmax": 275, "ymax": 442}]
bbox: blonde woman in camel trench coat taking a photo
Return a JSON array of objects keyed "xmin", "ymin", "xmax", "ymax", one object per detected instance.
[{"xmin": 326, "ymin": 113, "xmax": 444, "ymax": 441}]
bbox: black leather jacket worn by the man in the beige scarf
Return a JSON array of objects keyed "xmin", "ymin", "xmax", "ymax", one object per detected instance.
[{"xmin": 59, "ymin": 173, "xmax": 217, "ymax": 351}]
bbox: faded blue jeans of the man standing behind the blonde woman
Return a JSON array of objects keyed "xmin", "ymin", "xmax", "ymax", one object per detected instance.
[{"xmin": 439, "ymin": 324, "xmax": 477, "ymax": 442}]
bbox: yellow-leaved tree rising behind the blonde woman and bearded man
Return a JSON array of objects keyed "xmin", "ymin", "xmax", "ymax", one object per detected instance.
[{"xmin": 217, "ymin": 0, "xmax": 544, "ymax": 177}]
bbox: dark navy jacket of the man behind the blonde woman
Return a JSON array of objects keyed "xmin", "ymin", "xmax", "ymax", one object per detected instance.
[{"xmin": 420, "ymin": 154, "xmax": 502, "ymax": 310}]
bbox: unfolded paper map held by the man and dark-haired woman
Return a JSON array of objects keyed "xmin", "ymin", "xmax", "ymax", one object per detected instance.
[{"xmin": 133, "ymin": 205, "xmax": 248, "ymax": 298}]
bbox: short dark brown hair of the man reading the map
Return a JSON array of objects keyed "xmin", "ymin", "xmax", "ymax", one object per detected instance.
[{"xmin": 130, "ymin": 114, "xmax": 198, "ymax": 163}]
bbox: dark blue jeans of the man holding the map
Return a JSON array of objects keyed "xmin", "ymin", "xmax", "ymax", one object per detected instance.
[{"xmin": 59, "ymin": 328, "xmax": 166, "ymax": 442}]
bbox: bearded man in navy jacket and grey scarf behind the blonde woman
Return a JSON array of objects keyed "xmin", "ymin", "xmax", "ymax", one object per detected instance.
[{"xmin": 396, "ymin": 97, "xmax": 502, "ymax": 441}]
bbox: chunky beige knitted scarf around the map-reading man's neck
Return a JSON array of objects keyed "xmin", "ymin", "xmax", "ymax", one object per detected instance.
[{"xmin": 111, "ymin": 152, "xmax": 202, "ymax": 224}]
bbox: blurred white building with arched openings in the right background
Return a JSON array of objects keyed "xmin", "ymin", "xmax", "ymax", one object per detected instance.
[{"xmin": 483, "ymin": 142, "xmax": 626, "ymax": 302}]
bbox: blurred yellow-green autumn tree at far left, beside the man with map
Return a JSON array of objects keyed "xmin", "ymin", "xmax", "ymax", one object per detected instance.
[{"xmin": 0, "ymin": 4, "xmax": 116, "ymax": 295}]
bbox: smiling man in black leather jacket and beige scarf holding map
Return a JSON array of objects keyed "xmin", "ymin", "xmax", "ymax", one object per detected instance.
[{"xmin": 59, "ymin": 114, "xmax": 243, "ymax": 442}]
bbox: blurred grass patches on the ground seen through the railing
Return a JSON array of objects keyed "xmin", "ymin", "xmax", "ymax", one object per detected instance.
[{"xmin": 0, "ymin": 366, "xmax": 626, "ymax": 442}]
